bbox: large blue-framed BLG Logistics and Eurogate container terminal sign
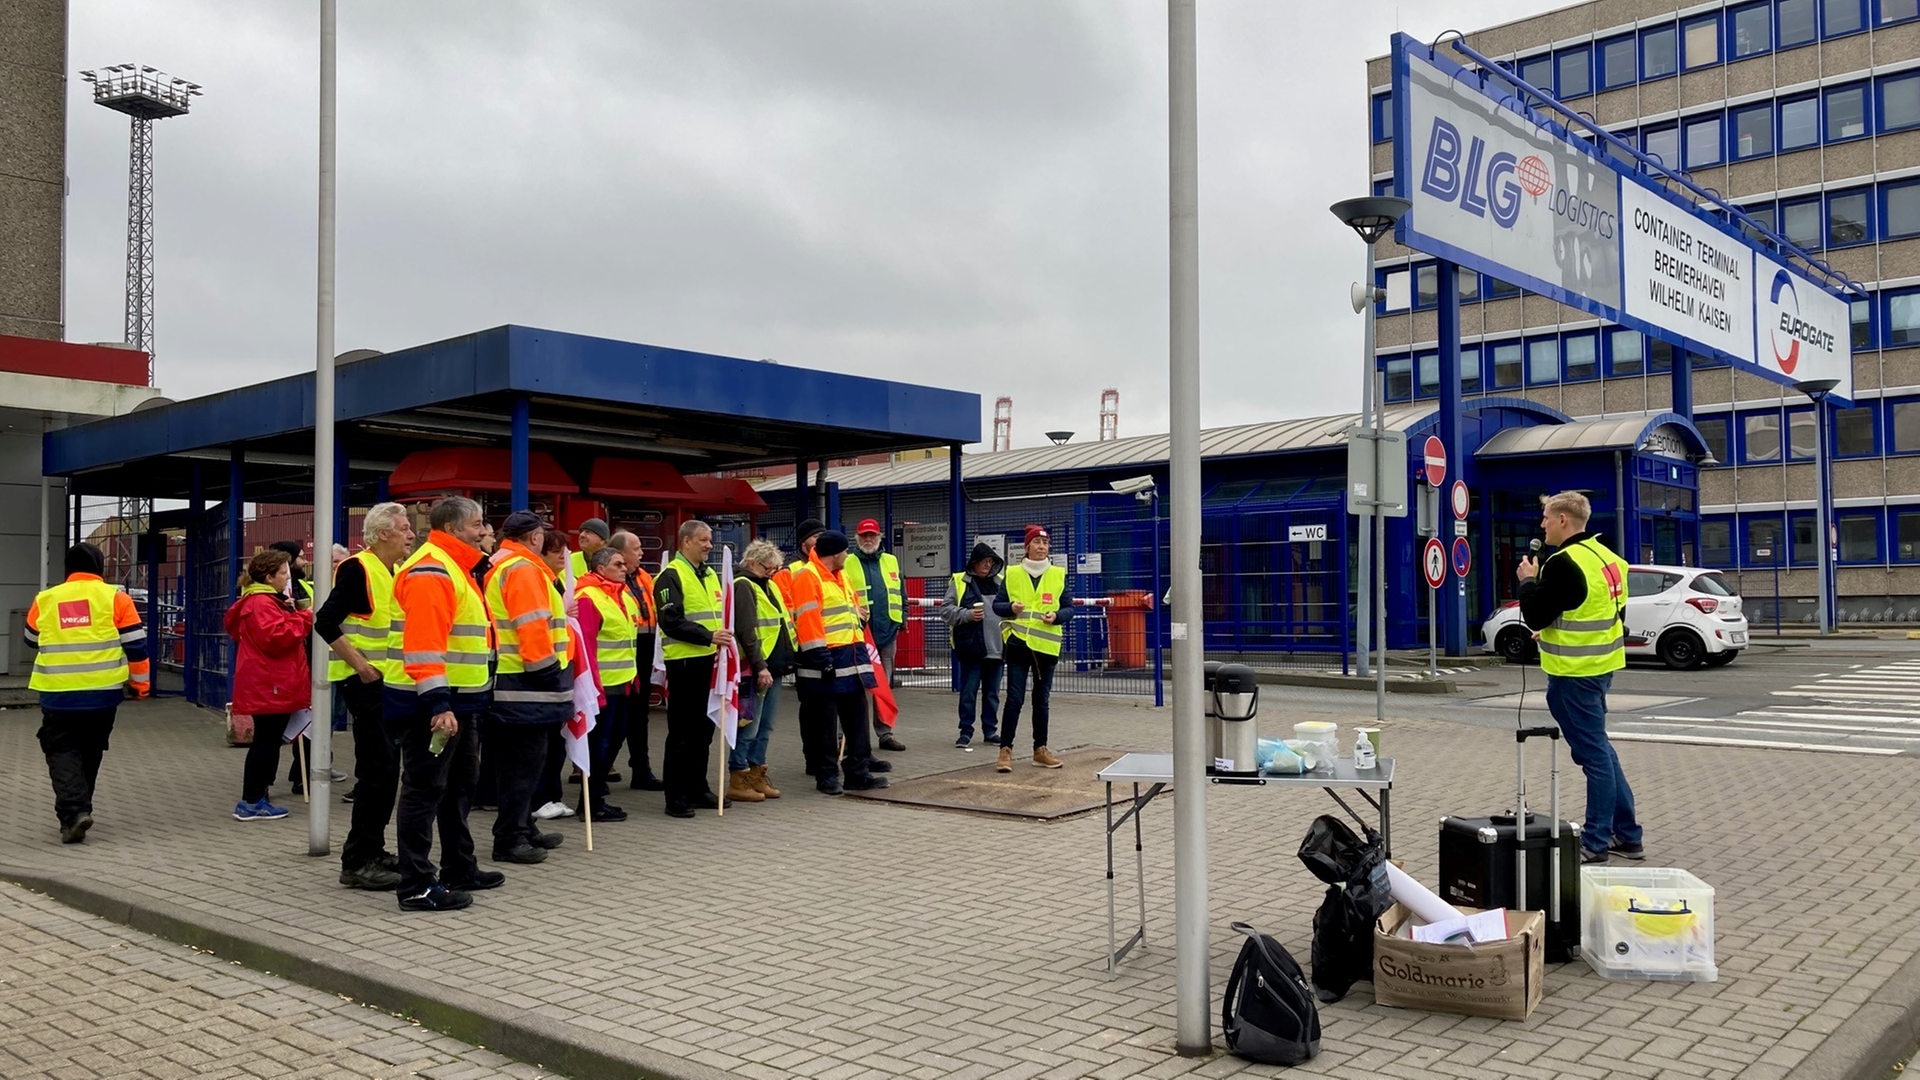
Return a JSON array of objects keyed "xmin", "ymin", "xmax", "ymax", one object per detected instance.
[{"xmin": 1394, "ymin": 35, "xmax": 1853, "ymax": 402}]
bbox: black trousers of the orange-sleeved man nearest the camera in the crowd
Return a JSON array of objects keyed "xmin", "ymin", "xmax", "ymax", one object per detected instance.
[{"xmin": 384, "ymin": 711, "xmax": 480, "ymax": 896}]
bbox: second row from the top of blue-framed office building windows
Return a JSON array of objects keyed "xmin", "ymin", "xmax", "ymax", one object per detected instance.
[{"xmin": 1609, "ymin": 71, "xmax": 1920, "ymax": 171}]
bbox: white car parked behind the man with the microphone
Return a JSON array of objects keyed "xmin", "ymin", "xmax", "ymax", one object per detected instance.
[{"xmin": 1480, "ymin": 567, "xmax": 1747, "ymax": 669}]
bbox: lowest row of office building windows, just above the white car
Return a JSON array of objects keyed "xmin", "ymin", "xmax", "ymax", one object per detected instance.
[{"xmin": 1699, "ymin": 505, "xmax": 1920, "ymax": 568}]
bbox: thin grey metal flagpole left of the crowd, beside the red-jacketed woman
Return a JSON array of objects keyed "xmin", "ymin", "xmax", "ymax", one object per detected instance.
[{"xmin": 307, "ymin": 0, "xmax": 340, "ymax": 855}]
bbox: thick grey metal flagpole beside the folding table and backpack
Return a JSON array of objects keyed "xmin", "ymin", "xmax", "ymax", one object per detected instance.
[{"xmin": 1167, "ymin": 0, "xmax": 1213, "ymax": 1057}]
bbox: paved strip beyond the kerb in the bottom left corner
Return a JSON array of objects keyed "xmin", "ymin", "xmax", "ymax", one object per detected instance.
[{"xmin": 0, "ymin": 884, "xmax": 553, "ymax": 1080}]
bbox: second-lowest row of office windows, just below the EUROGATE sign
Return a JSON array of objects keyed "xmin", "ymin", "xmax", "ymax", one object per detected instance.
[{"xmin": 1693, "ymin": 398, "xmax": 1920, "ymax": 465}]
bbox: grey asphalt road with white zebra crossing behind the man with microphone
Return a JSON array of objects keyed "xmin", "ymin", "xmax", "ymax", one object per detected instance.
[{"xmin": 1286, "ymin": 638, "xmax": 1920, "ymax": 755}]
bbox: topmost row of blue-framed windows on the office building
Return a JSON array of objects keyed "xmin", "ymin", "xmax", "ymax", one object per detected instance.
[{"xmin": 1373, "ymin": 0, "xmax": 1920, "ymax": 143}]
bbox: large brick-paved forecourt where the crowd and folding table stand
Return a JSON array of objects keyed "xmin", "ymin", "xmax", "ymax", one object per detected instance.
[{"xmin": 0, "ymin": 688, "xmax": 1920, "ymax": 1080}]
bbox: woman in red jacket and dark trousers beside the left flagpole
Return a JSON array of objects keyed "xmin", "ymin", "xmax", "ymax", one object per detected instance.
[{"xmin": 227, "ymin": 548, "xmax": 313, "ymax": 821}]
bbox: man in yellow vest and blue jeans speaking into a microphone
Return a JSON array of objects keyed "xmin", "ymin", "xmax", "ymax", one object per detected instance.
[{"xmin": 1517, "ymin": 492, "xmax": 1647, "ymax": 865}]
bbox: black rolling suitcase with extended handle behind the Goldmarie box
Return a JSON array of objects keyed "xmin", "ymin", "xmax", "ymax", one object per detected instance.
[{"xmin": 1440, "ymin": 726, "xmax": 1580, "ymax": 963}]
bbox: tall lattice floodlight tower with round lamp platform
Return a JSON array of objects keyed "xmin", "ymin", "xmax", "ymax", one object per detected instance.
[{"xmin": 81, "ymin": 63, "xmax": 200, "ymax": 378}]
